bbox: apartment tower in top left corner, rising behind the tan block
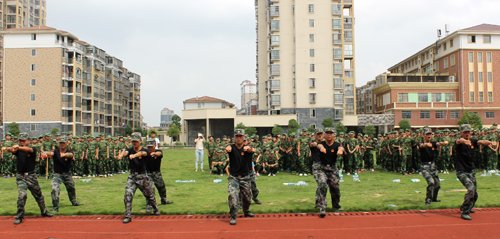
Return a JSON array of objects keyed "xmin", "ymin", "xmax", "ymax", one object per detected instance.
[{"xmin": 0, "ymin": 0, "xmax": 47, "ymax": 124}]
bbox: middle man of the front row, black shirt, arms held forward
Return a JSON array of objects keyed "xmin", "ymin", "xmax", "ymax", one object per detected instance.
[{"xmin": 226, "ymin": 129, "xmax": 255, "ymax": 225}]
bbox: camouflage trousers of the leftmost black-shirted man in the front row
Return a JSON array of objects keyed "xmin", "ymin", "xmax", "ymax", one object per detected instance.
[{"xmin": 16, "ymin": 173, "xmax": 47, "ymax": 218}]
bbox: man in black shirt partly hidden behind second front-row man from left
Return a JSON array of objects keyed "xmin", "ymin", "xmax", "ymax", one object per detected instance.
[{"xmin": 146, "ymin": 138, "xmax": 174, "ymax": 211}]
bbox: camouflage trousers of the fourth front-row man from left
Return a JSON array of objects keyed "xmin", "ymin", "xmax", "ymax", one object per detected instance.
[{"xmin": 316, "ymin": 165, "xmax": 340, "ymax": 209}]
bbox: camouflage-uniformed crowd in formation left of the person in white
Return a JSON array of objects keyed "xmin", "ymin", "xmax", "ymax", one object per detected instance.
[{"xmin": 0, "ymin": 132, "xmax": 165, "ymax": 178}]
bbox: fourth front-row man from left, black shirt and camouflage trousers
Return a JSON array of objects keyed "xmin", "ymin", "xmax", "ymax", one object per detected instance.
[{"xmin": 316, "ymin": 127, "xmax": 344, "ymax": 218}]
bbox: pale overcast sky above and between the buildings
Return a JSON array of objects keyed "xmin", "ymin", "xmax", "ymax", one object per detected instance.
[{"xmin": 47, "ymin": 0, "xmax": 500, "ymax": 126}]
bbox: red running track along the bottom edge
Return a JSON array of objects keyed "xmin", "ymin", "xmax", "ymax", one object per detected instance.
[{"xmin": 0, "ymin": 208, "xmax": 500, "ymax": 239}]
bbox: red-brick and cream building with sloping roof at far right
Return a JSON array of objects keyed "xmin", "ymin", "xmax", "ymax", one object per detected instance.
[{"xmin": 373, "ymin": 24, "xmax": 500, "ymax": 128}]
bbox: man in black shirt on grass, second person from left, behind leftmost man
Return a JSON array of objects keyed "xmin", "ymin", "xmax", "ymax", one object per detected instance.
[{"xmin": 42, "ymin": 136, "xmax": 83, "ymax": 212}]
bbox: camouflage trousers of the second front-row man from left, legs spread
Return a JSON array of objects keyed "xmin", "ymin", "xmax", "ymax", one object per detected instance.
[{"xmin": 123, "ymin": 173, "xmax": 158, "ymax": 218}]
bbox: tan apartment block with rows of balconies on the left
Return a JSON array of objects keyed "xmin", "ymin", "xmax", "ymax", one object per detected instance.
[{"xmin": 0, "ymin": 26, "xmax": 142, "ymax": 135}]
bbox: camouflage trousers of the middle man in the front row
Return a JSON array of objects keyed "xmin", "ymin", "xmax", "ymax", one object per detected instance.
[{"xmin": 227, "ymin": 174, "xmax": 252, "ymax": 217}]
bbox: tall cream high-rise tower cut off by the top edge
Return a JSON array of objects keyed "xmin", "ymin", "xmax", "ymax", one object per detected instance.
[{"xmin": 255, "ymin": 0, "xmax": 356, "ymax": 128}]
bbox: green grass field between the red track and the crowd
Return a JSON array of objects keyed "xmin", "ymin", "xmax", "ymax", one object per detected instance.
[{"xmin": 0, "ymin": 149, "xmax": 500, "ymax": 215}]
